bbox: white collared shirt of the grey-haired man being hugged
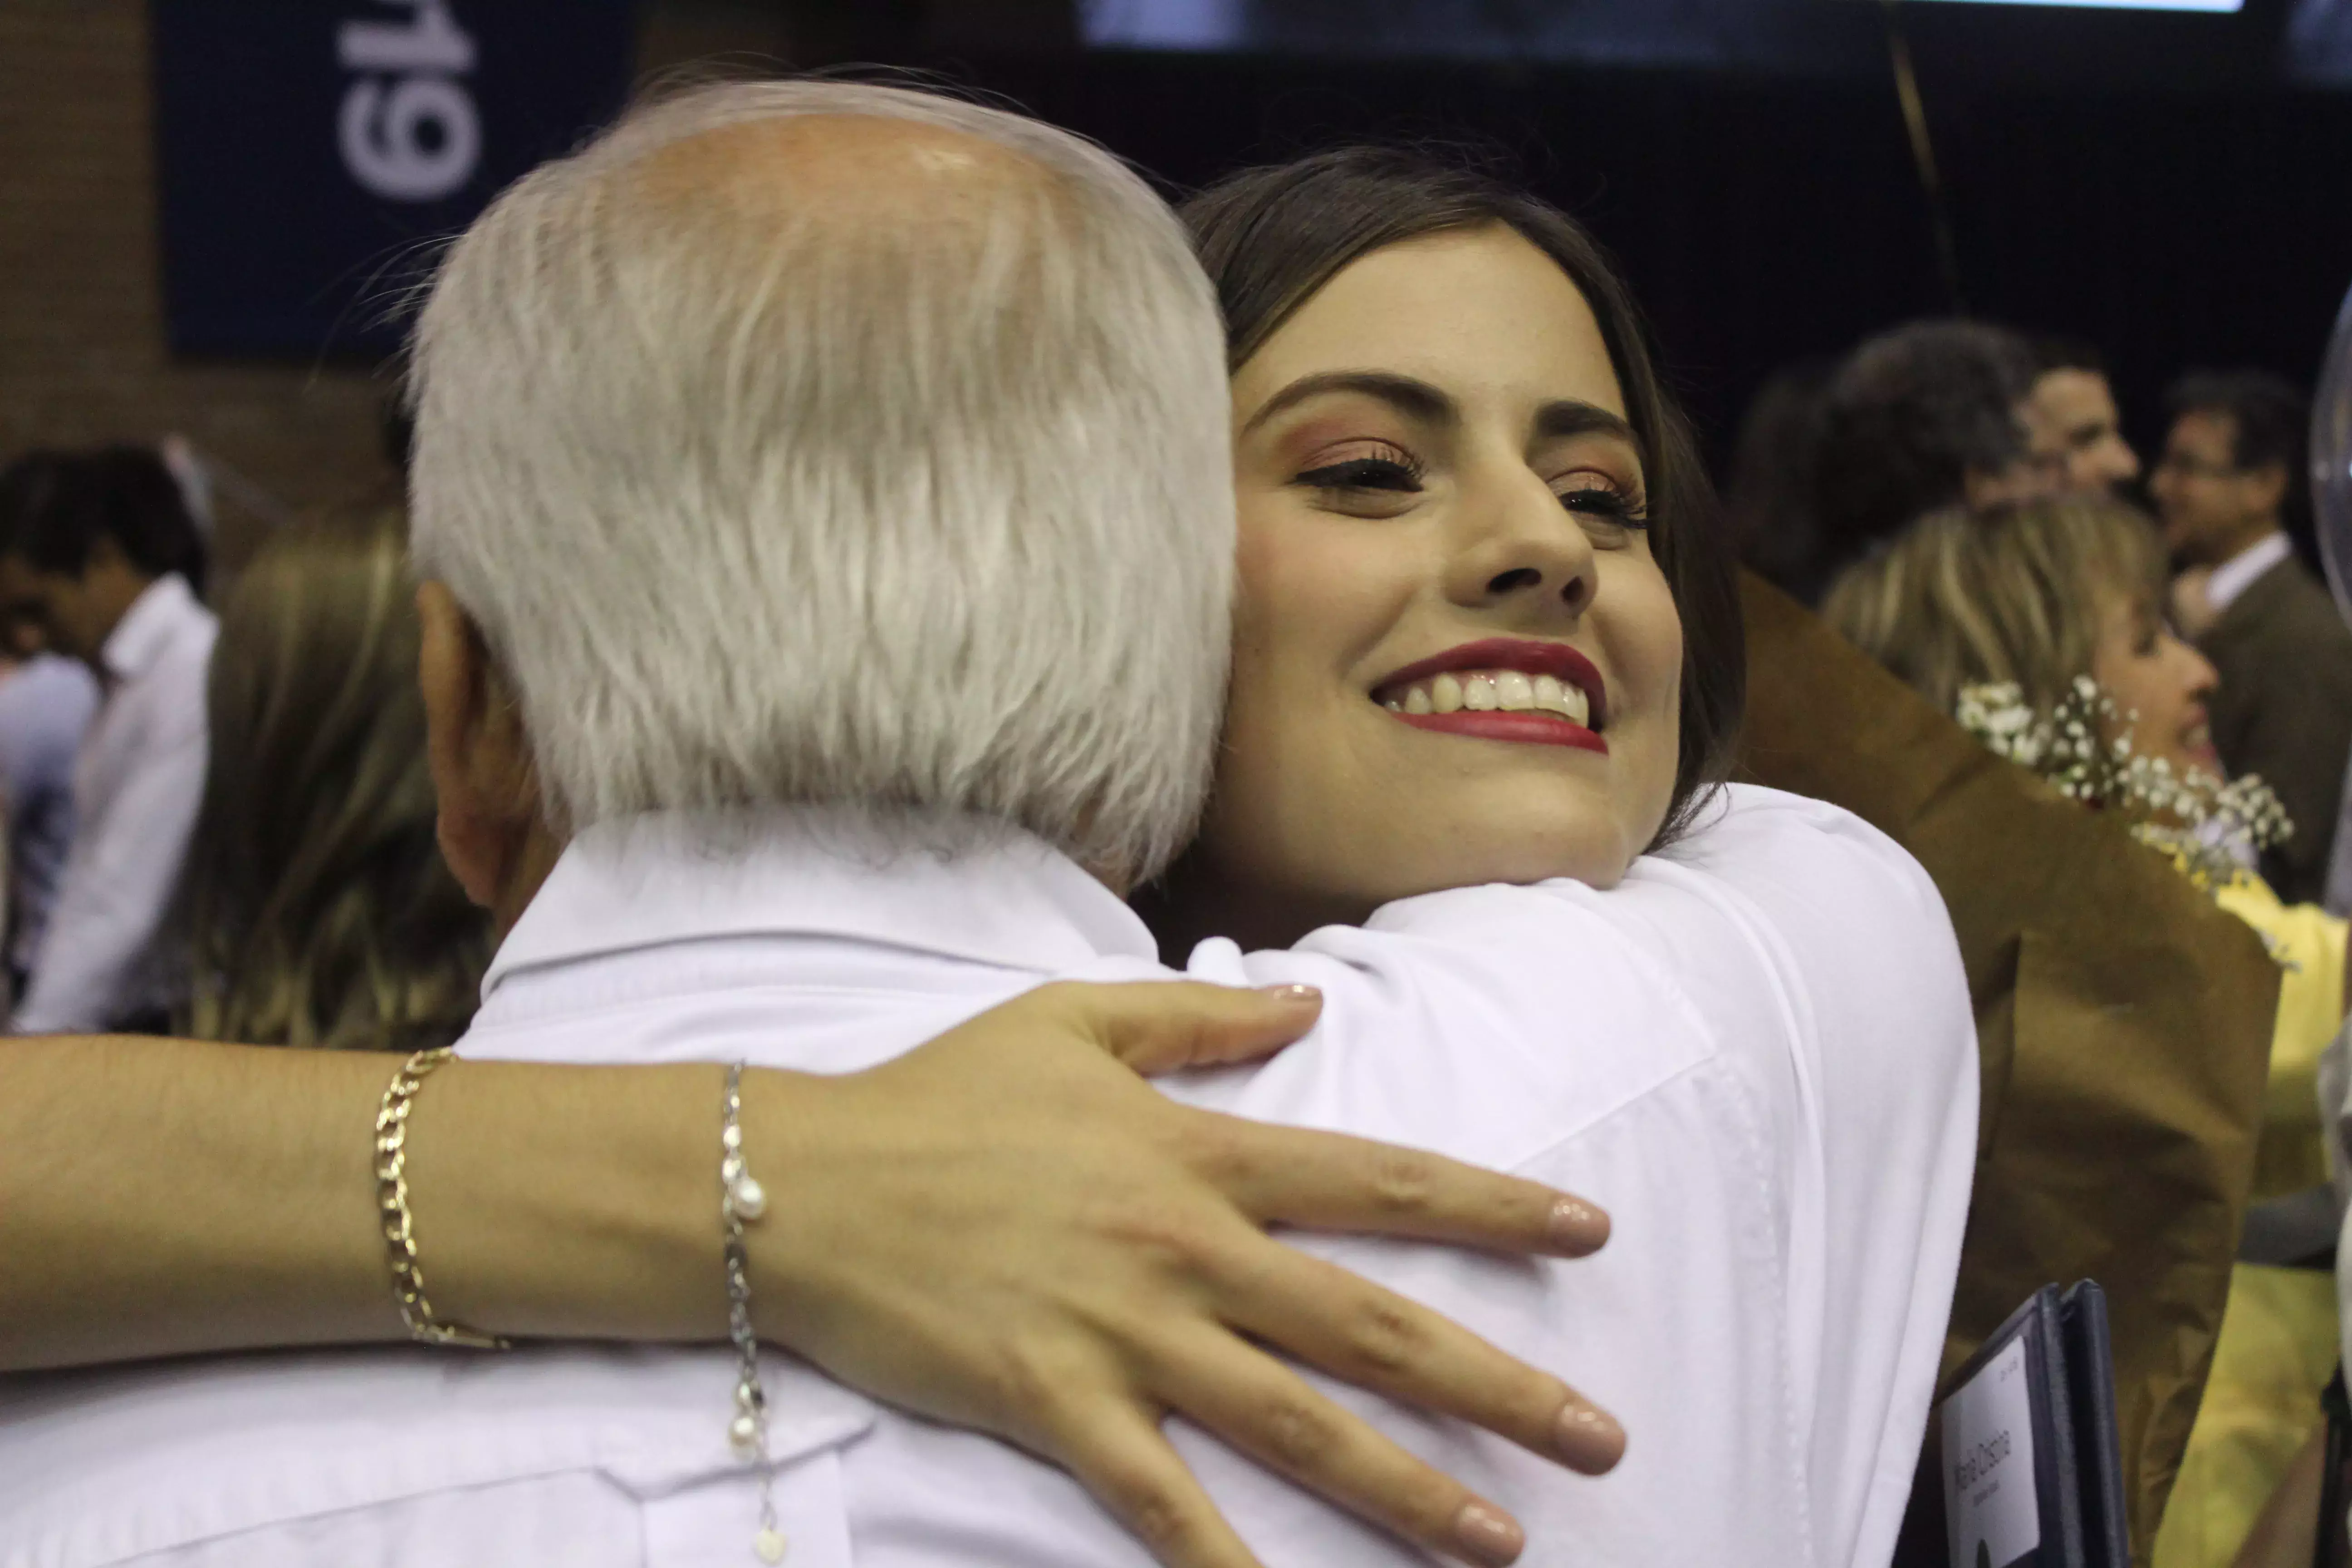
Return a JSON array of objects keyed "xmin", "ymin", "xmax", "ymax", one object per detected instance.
[{"xmin": 0, "ymin": 790, "xmax": 1976, "ymax": 1568}]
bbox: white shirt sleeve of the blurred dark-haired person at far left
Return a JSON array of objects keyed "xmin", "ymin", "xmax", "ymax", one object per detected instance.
[{"xmin": 12, "ymin": 724, "xmax": 207, "ymax": 1034}]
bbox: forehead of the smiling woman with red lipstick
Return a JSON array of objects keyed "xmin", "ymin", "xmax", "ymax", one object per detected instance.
[{"xmin": 1235, "ymin": 223, "xmax": 1625, "ymax": 416}]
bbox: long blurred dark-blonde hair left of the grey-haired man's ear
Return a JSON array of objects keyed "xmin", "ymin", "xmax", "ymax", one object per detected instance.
[{"xmin": 186, "ymin": 510, "xmax": 489, "ymax": 1051}]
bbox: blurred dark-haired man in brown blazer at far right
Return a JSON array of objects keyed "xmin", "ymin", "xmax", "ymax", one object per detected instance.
[{"xmin": 2147, "ymin": 372, "xmax": 2352, "ymax": 903}]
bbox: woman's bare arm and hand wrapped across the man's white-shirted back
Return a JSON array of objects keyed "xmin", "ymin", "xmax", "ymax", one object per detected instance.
[{"xmin": 0, "ymin": 985, "xmax": 1616, "ymax": 1568}]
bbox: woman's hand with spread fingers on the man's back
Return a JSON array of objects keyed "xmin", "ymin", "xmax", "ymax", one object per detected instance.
[{"xmin": 743, "ymin": 983, "xmax": 1623, "ymax": 1568}]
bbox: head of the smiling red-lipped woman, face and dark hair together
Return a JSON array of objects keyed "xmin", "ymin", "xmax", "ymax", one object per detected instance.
[{"xmin": 1160, "ymin": 148, "xmax": 1745, "ymax": 952}]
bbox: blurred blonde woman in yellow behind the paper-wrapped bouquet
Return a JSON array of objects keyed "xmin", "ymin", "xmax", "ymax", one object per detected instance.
[{"xmin": 1823, "ymin": 501, "xmax": 2345, "ymax": 1568}]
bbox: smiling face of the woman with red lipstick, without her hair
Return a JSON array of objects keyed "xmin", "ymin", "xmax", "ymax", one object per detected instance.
[{"xmin": 1197, "ymin": 225, "xmax": 1682, "ymax": 929}]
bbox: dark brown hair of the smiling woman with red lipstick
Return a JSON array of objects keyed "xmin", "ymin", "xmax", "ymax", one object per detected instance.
[{"xmin": 1181, "ymin": 146, "xmax": 1748, "ymax": 848}]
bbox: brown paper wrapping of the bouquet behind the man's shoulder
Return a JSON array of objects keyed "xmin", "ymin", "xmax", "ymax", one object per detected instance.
[{"xmin": 1740, "ymin": 576, "xmax": 2279, "ymax": 1561}]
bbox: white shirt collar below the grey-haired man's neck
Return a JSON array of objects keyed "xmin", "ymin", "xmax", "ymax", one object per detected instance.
[{"xmin": 482, "ymin": 806, "xmax": 1157, "ymax": 999}]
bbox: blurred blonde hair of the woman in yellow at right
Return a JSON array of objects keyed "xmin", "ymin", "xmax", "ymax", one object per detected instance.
[{"xmin": 1820, "ymin": 498, "xmax": 2164, "ymax": 712}]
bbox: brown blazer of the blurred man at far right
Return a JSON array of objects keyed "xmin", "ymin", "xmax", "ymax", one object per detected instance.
[{"xmin": 2197, "ymin": 555, "xmax": 2352, "ymax": 903}]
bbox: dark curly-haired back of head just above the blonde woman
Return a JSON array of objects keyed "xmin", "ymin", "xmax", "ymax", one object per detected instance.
[{"xmin": 1813, "ymin": 320, "xmax": 2037, "ymax": 557}]
